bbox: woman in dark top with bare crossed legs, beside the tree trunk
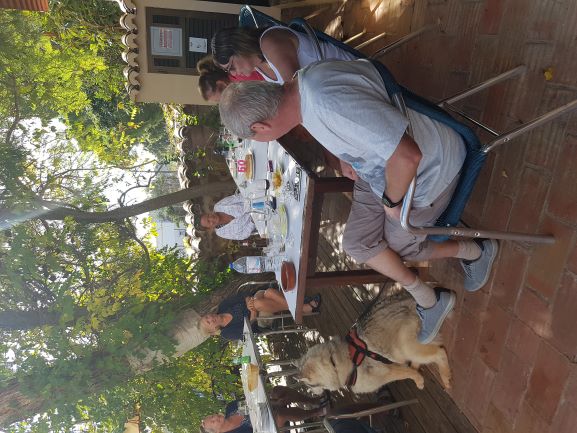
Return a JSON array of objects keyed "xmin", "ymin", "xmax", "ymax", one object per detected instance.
[{"xmin": 198, "ymin": 288, "xmax": 321, "ymax": 341}]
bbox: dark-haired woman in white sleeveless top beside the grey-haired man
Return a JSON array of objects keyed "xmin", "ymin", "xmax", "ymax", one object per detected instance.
[{"xmin": 212, "ymin": 26, "xmax": 356, "ymax": 84}]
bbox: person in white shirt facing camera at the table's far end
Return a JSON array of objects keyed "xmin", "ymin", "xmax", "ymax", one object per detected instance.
[{"xmin": 200, "ymin": 194, "xmax": 256, "ymax": 240}]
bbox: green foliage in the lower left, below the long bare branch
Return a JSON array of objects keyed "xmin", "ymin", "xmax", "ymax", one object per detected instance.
[{"xmin": 0, "ymin": 221, "xmax": 239, "ymax": 432}]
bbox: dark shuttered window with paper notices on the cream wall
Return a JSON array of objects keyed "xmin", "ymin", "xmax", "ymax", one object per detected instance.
[{"xmin": 146, "ymin": 8, "xmax": 238, "ymax": 75}]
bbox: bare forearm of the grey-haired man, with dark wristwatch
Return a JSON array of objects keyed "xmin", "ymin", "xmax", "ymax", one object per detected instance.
[{"xmin": 385, "ymin": 133, "xmax": 423, "ymax": 216}]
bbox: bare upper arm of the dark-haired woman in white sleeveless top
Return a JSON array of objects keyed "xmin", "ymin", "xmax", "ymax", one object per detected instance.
[{"xmin": 260, "ymin": 29, "xmax": 300, "ymax": 81}]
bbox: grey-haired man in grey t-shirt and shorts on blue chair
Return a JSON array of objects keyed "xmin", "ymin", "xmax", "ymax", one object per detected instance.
[{"xmin": 220, "ymin": 60, "xmax": 498, "ymax": 343}]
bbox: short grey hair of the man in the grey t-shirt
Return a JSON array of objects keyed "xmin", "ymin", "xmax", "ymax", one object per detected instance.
[{"xmin": 219, "ymin": 81, "xmax": 284, "ymax": 138}]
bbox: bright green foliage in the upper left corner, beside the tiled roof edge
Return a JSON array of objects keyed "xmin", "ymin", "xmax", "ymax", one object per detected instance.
[{"xmin": 0, "ymin": 4, "xmax": 168, "ymax": 164}]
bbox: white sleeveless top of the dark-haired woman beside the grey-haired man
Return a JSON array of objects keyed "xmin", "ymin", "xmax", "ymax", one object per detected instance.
[{"xmin": 256, "ymin": 26, "xmax": 356, "ymax": 84}]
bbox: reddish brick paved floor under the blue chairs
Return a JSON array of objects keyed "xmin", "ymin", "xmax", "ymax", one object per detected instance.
[{"xmin": 282, "ymin": 0, "xmax": 577, "ymax": 433}]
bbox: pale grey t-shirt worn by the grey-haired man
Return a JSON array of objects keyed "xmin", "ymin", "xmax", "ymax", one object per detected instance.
[{"xmin": 297, "ymin": 60, "xmax": 466, "ymax": 207}]
